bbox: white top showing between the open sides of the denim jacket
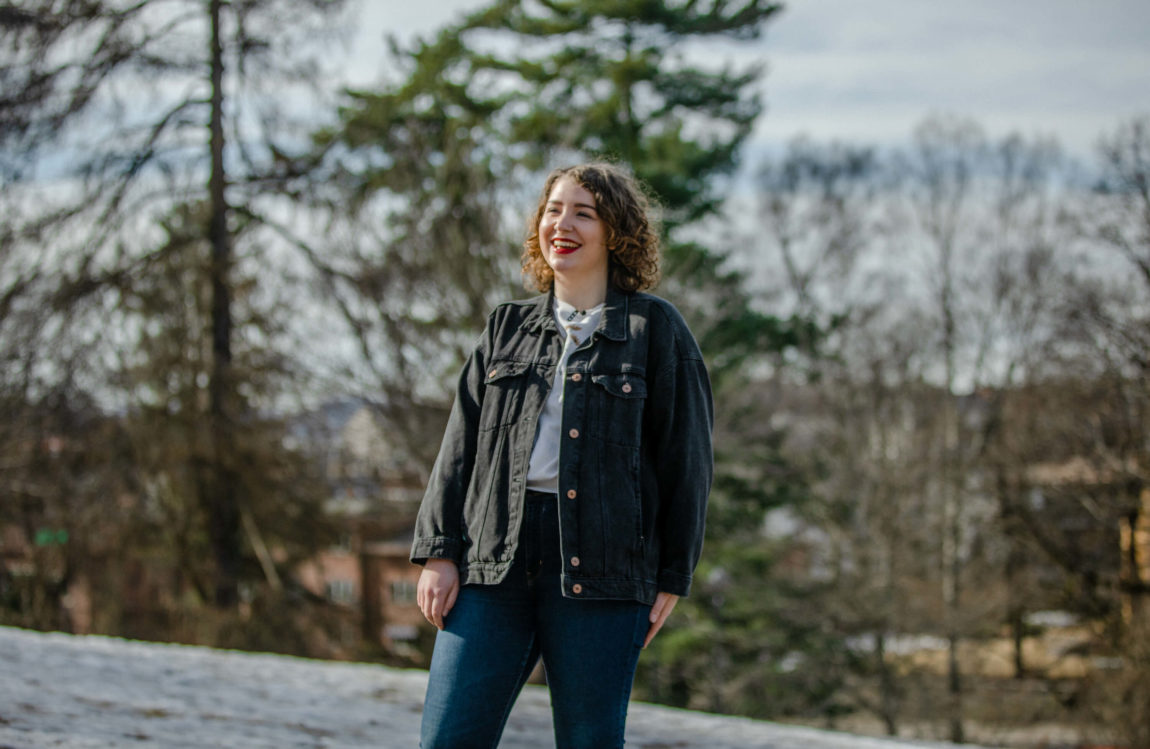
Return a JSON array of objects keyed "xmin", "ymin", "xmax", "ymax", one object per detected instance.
[{"xmin": 527, "ymin": 299, "xmax": 604, "ymax": 494}]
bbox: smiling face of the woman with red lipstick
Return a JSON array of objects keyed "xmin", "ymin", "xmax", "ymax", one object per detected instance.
[{"xmin": 539, "ymin": 176, "xmax": 607, "ymax": 291}]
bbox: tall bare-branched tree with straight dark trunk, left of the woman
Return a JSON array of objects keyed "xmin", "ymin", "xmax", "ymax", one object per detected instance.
[{"xmin": 0, "ymin": 0, "xmax": 342, "ymax": 609}]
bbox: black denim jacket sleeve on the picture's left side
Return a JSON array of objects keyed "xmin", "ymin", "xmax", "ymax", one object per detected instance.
[{"xmin": 411, "ymin": 320, "xmax": 490, "ymax": 564}]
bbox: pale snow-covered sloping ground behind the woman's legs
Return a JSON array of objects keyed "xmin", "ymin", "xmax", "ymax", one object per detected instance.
[{"xmin": 0, "ymin": 627, "xmax": 989, "ymax": 749}]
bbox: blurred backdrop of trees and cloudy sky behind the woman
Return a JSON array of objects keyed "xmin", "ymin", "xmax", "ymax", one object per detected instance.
[{"xmin": 0, "ymin": 0, "xmax": 1150, "ymax": 749}]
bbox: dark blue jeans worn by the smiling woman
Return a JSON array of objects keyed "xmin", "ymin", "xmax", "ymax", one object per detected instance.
[{"xmin": 420, "ymin": 492, "xmax": 651, "ymax": 749}]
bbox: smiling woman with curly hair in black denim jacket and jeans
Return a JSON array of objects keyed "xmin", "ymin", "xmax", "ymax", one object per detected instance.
[{"xmin": 411, "ymin": 163, "xmax": 713, "ymax": 749}]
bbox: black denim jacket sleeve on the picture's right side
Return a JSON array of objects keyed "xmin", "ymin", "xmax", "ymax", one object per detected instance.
[{"xmin": 650, "ymin": 312, "xmax": 714, "ymax": 596}]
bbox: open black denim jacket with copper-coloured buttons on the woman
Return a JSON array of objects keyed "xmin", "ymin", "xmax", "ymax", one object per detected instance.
[{"xmin": 411, "ymin": 289, "xmax": 714, "ymax": 604}]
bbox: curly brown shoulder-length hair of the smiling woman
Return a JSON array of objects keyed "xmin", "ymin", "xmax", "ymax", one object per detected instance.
[{"xmin": 521, "ymin": 161, "xmax": 659, "ymax": 291}]
